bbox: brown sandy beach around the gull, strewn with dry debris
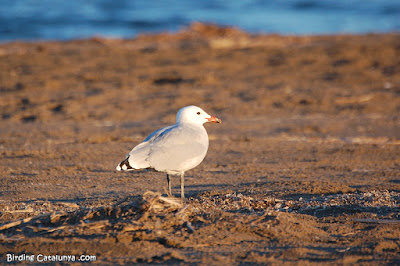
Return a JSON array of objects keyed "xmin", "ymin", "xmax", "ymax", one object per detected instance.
[{"xmin": 0, "ymin": 24, "xmax": 400, "ymax": 265}]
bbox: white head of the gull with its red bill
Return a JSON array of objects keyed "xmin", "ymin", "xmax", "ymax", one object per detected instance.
[{"xmin": 176, "ymin": 105, "xmax": 222, "ymax": 125}]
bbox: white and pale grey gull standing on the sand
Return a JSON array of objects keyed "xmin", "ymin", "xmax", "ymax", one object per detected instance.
[{"xmin": 116, "ymin": 105, "xmax": 222, "ymax": 199}]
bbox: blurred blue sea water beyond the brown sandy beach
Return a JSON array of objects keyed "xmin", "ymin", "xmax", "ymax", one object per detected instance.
[{"xmin": 0, "ymin": 0, "xmax": 400, "ymax": 41}]
